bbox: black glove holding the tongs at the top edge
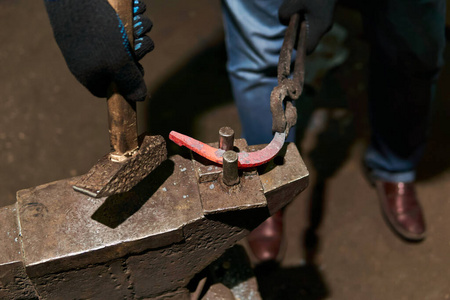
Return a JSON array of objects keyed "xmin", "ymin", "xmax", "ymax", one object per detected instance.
[{"xmin": 278, "ymin": 0, "xmax": 336, "ymax": 54}]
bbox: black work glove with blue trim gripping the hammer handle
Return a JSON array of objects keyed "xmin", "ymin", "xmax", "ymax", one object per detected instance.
[{"xmin": 44, "ymin": 0, "xmax": 154, "ymax": 101}]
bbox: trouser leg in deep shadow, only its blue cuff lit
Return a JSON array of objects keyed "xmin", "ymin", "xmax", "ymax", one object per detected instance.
[{"xmin": 363, "ymin": 0, "xmax": 445, "ymax": 182}]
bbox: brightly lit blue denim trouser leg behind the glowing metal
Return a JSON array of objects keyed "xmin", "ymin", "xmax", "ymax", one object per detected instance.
[{"xmin": 222, "ymin": 0, "xmax": 295, "ymax": 145}]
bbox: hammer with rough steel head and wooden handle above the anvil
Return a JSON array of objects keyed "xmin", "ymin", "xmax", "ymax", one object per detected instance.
[{"xmin": 73, "ymin": 0, "xmax": 167, "ymax": 198}]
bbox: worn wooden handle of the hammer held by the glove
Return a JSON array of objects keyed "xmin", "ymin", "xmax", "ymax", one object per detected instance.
[{"xmin": 107, "ymin": 0, "xmax": 139, "ymax": 161}]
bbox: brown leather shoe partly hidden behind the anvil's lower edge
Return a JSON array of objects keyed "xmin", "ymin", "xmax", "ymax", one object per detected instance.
[{"xmin": 247, "ymin": 210, "xmax": 283, "ymax": 262}]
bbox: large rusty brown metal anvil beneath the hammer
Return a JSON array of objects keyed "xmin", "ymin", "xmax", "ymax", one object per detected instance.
[{"xmin": 0, "ymin": 127, "xmax": 309, "ymax": 299}]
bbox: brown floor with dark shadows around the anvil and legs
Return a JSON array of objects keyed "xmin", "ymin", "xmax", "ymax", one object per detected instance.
[{"xmin": 0, "ymin": 0, "xmax": 450, "ymax": 300}]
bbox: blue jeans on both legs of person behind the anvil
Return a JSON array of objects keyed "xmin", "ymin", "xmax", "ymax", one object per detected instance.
[{"xmin": 222, "ymin": 0, "xmax": 445, "ymax": 181}]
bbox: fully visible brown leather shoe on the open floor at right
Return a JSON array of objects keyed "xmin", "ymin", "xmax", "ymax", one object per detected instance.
[{"xmin": 375, "ymin": 180, "xmax": 425, "ymax": 241}]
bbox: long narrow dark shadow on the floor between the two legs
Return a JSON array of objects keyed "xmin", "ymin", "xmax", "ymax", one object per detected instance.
[{"xmin": 298, "ymin": 69, "xmax": 355, "ymax": 258}]
